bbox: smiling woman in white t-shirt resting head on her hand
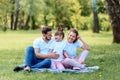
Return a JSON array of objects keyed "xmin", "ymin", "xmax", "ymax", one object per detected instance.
[{"xmin": 62, "ymin": 29, "xmax": 89, "ymax": 69}]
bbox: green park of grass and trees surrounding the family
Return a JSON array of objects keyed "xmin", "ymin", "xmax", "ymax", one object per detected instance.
[{"xmin": 0, "ymin": 0, "xmax": 120, "ymax": 80}]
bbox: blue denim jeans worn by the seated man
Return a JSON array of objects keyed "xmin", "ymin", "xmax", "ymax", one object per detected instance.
[{"xmin": 25, "ymin": 46, "xmax": 51, "ymax": 68}]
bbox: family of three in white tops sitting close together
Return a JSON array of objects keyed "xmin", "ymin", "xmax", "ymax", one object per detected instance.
[{"xmin": 14, "ymin": 27, "xmax": 89, "ymax": 71}]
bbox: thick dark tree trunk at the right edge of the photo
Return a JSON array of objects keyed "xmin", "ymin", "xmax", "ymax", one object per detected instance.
[{"xmin": 106, "ymin": 0, "xmax": 120, "ymax": 43}]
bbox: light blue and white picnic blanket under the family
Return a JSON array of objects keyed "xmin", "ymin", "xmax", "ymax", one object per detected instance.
[{"xmin": 14, "ymin": 64, "xmax": 99, "ymax": 73}]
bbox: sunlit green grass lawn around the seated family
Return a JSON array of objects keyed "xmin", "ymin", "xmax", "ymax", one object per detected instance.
[{"xmin": 0, "ymin": 30, "xmax": 120, "ymax": 80}]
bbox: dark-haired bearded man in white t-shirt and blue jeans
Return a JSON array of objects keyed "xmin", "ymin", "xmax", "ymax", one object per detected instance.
[{"xmin": 14, "ymin": 27, "xmax": 59, "ymax": 71}]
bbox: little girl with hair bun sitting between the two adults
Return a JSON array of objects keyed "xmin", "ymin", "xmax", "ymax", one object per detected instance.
[{"xmin": 50, "ymin": 28, "xmax": 66, "ymax": 70}]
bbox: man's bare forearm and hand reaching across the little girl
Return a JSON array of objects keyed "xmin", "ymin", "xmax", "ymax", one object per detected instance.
[{"xmin": 34, "ymin": 48, "xmax": 59, "ymax": 59}]
